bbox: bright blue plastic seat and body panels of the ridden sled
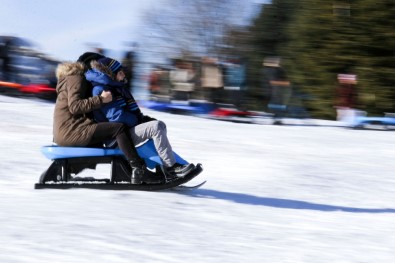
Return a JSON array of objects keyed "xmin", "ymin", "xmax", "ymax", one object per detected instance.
[{"xmin": 41, "ymin": 140, "xmax": 188, "ymax": 168}]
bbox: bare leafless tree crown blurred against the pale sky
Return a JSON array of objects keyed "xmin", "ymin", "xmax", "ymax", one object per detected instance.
[{"xmin": 144, "ymin": 0, "xmax": 245, "ymax": 60}]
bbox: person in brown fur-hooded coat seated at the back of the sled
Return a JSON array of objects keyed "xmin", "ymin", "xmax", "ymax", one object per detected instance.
[{"xmin": 53, "ymin": 52, "xmax": 162, "ymax": 183}]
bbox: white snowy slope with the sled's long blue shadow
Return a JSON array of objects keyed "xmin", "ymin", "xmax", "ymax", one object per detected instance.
[{"xmin": 0, "ymin": 96, "xmax": 395, "ymax": 263}]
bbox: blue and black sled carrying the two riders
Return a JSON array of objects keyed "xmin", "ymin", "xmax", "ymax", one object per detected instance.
[{"xmin": 35, "ymin": 140, "xmax": 203, "ymax": 191}]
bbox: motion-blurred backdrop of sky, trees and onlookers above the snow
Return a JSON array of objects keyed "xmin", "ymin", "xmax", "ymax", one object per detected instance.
[{"xmin": 0, "ymin": 0, "xmax": 395, "ymax": 120}]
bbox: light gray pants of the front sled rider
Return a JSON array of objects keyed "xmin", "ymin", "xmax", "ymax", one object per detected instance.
[{"xmin": 130, "ymin": 121, "xmax": 176, "ymax": 167}]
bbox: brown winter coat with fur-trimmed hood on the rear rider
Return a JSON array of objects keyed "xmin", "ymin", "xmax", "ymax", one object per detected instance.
[{"xmin": 53, "ymin": 62, "xmax": 102, "ymax": 146}]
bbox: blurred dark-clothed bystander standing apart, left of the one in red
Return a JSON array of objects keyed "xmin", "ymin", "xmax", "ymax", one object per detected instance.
[{"xmin": 263, "ymin": 57, "xmax": 292, "ymax": 124}]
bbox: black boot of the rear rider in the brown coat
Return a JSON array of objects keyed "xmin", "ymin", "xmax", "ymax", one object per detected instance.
[{"xmin": 129, "ymin": 159, "xmax": 164, "ymax": 184}]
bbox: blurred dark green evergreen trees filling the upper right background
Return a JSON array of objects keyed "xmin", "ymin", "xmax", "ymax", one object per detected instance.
[{"xmin": 244, "ymin": 0, "xmax": 395, "ymax": 118}]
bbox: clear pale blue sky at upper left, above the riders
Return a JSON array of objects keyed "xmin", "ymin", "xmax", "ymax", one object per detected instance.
[{"xmin": 0, "ymin": 0, "xmax": 265, "ymax": 60}]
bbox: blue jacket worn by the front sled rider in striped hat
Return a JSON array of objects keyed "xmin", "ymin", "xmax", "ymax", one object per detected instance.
[{"xmin": 85, "ymin": 68, "xmax": 143, "ymax": 127}]
